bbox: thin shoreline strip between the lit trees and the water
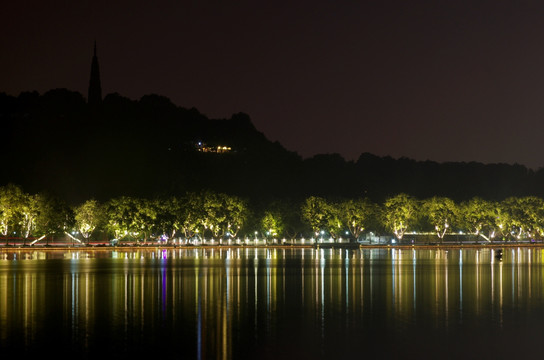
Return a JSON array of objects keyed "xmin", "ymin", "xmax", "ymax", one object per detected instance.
[{"xmin": 0, "ymin": 243, "xmax": 544, "ymax": 252}]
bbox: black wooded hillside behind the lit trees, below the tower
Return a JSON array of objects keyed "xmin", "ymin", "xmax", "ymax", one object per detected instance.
[{"xmin": 0, "ymin": 89, "xmax": 544, "ymax": 208}]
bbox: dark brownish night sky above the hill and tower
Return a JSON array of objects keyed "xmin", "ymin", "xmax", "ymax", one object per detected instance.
[{"xmin": 0, "ymin": 0, "xmax": 544, "ymax": 168}]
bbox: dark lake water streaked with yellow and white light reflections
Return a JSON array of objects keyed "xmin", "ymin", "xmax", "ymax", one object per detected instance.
[{"xmin": 0, "ymin": 246, "xmax": 544, "ymax": 359}]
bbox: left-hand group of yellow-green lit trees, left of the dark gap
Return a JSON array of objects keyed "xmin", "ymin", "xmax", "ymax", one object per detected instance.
[{"xmin": 0, "ymin": 185, "xmax": 248, "ymax": 242}]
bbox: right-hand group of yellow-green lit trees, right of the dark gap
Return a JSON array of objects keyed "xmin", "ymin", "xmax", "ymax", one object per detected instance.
[{"xmin": 270, "ymin": 194, "xmax": 544, "ymax": 241}]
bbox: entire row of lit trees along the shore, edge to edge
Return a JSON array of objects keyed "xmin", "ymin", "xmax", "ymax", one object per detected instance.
[{"xmin": 0, "ymin": 185, "xmax": 544, "ymax": 242}]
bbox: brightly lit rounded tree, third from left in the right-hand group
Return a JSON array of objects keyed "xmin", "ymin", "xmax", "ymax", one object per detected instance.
[{"xmin": 382, "ymin": 194, "xmax": 417, "ymax": 240}]
